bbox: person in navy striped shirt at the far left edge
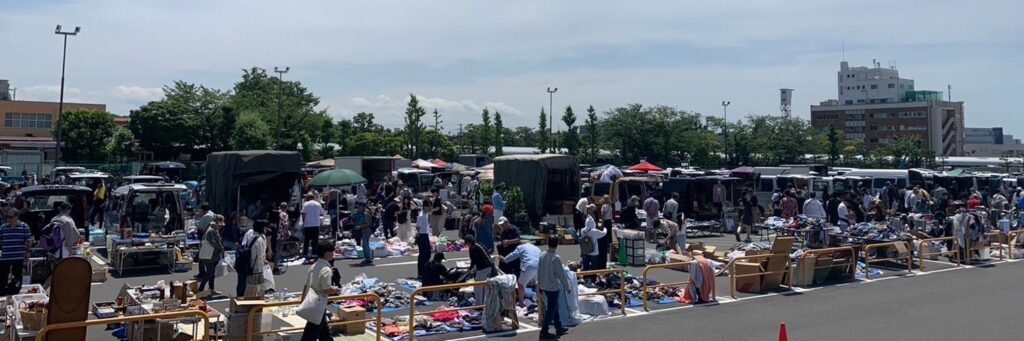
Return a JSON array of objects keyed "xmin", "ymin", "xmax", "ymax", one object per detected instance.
[{"xmin": 0, "ymin": 209, "xmax": 32, "ymax": 296}]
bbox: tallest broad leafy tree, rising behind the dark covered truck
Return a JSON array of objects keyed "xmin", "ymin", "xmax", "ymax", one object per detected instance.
[{"xmin": 231, "ymin": 68, "xmax": 327, "ymax": 151}]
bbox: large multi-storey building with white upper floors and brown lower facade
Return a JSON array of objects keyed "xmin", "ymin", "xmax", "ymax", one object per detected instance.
[{"xmin": 811, "ymin": 61, "xmax": 965, "ymax": 156}]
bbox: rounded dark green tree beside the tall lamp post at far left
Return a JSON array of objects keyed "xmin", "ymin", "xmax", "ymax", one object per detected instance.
[{"xmin": 53, "ymin": 110, "xmax": 114, "ymax": 162}]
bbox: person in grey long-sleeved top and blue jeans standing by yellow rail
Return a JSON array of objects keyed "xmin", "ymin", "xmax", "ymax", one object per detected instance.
[{"xmin": 537, "ymin": 236, "xmax": 572, "ymax": 339}]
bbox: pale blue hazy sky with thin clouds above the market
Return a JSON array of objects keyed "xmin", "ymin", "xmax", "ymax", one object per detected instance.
[{"xmin": 0, "ymin": 0, "xmax": 1024, "ymax": 135}]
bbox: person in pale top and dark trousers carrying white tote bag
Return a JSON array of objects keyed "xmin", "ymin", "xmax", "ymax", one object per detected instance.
[{"xmin": 299, "ymin": 241, "xmax": 341, "ymax": 341}]
